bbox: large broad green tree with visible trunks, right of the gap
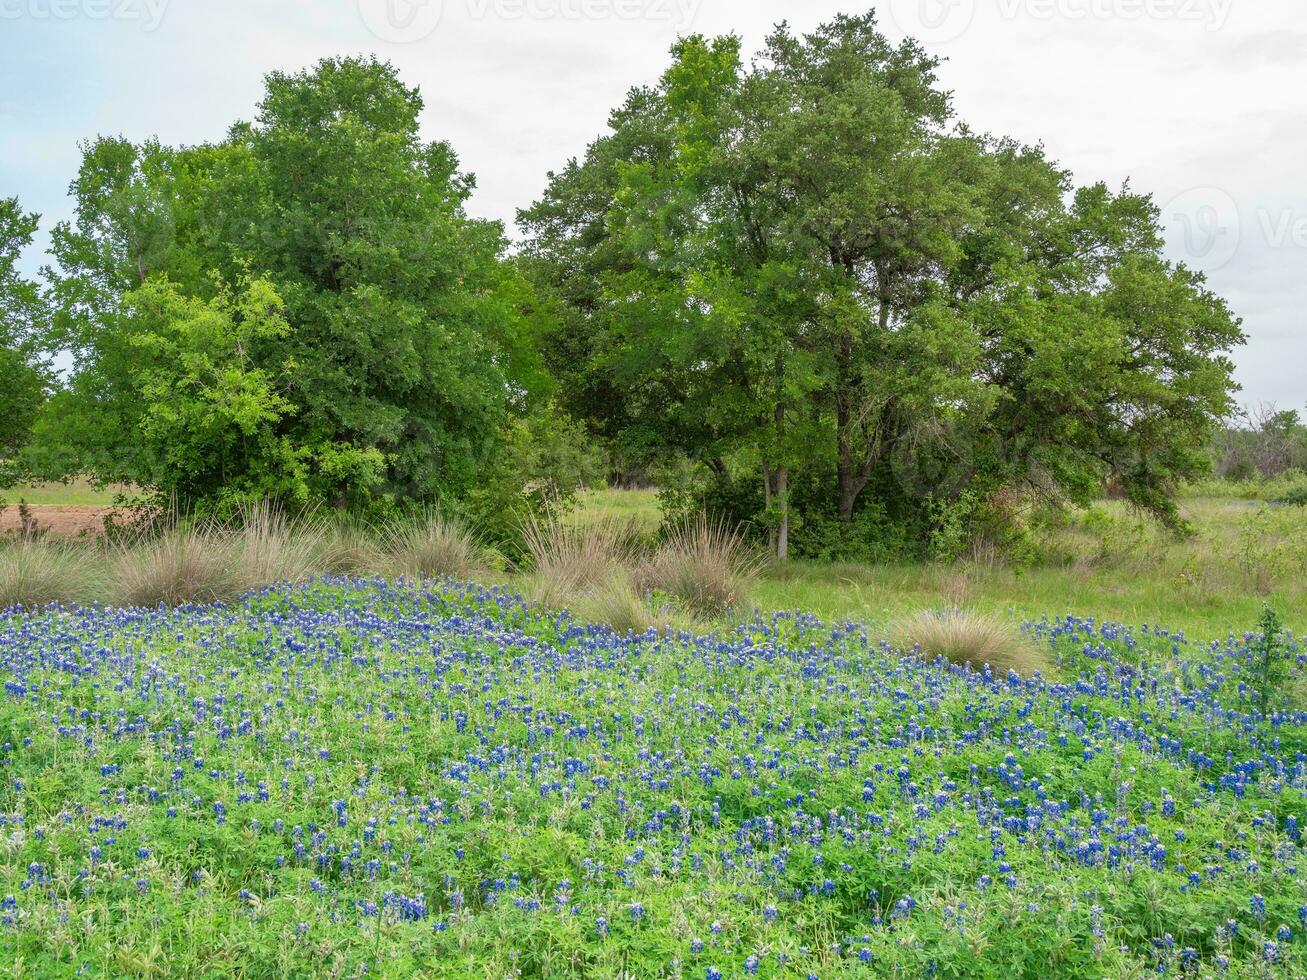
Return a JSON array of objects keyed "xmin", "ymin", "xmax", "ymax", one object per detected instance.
[{"xmin": 521, "ymin": 14, "xmax": 1242, "ymax": 559}]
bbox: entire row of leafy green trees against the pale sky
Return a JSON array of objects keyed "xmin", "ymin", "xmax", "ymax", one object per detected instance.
[{"xmin": 0, "ymin": 13, "xmax": 1244, "ymax": 557}]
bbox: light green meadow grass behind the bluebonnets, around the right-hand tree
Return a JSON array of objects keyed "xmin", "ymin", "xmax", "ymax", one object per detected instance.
[{"xmin": 583, "ymin": 490, "xmax": 1307, "ymax": 638}]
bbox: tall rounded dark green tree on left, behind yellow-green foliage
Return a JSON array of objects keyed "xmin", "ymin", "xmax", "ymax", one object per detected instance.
[{"xmin": 42, "ymin": 59, "xmax": 541, "ymax": 506}]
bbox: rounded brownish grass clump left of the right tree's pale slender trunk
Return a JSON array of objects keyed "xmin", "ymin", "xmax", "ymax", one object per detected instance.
[{"xmin": 639, "ymin": 516, "xmax": 761, "ymax": 617}]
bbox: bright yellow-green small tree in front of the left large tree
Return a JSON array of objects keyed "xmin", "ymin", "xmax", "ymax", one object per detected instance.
[{"xmin": 31, "ymin": 276, "xmax": 368, "ymax": 516}]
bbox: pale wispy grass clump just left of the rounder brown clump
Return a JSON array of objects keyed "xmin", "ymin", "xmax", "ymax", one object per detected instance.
[{"xmin": 523, "ymin": 514, "xmax": 638, "ymax": 605}]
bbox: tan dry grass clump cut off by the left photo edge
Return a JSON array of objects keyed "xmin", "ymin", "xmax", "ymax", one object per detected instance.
[{"xmin": 0, "ymin": 537, "xmax": 107, "ymax": 610}]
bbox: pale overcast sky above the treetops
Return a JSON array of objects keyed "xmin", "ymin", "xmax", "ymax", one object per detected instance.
[{"xmin": 0, "ymin": 0, "xmax": 1307, "ymax": 408}]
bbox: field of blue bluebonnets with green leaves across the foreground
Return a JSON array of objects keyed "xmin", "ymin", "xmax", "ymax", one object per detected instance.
[{"xmin": 0, "ymin": 579, "xmax": 1307, "ymax": 979}]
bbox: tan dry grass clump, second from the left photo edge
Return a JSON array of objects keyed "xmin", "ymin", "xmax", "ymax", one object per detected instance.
[{"xmin": 114, "ymin": 521, "xmax": 246, "ymax": 608}]
